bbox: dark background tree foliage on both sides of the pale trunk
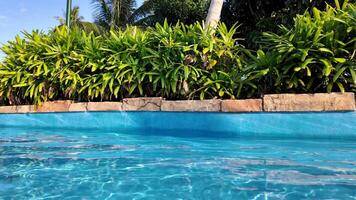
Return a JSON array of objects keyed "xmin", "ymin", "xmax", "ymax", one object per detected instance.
[{"xmin": 129, "ymin": 0, "xmax": 355, "ymax": 48}]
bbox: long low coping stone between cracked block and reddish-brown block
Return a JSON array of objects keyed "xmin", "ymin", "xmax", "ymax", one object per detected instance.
[{"xmin": 161, "ymin": 100, "xmax": 221, "ymax": 112}]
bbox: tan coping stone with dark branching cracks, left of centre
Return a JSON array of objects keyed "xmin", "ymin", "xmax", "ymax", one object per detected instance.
[{"xmin": 123, "ymin": 97, "xmax": 162, "ymax": 111}]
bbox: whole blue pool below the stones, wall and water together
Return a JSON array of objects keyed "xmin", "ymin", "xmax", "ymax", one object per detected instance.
[{"xmin": 0, "ymin": 112, "xmax": 356, "ymax": 200}]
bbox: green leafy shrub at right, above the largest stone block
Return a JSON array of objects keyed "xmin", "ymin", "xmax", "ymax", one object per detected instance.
[{"xmin": 251, "ymin": 1, "xmax": 356, "ymax": 93}]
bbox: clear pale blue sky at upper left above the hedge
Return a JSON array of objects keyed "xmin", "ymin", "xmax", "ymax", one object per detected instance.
[{"xmin": 0, "ymin": 0, "xmax": 143, "ymax": 50}]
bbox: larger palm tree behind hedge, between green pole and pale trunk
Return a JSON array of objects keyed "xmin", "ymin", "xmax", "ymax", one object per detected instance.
[{"xmin": 93, "ymin": 0, "xmax": 136, "ymax": 29}]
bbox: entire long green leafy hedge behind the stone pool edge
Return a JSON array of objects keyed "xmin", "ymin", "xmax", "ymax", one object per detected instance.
[{"xmin": 0, "ymin": 2, "xmax": 356, "ymax": 105}]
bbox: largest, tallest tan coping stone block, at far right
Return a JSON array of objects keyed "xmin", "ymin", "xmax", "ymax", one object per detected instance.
[{"xmin": 263, "ymin": 93, "xmax": 355, "ymax": 112}]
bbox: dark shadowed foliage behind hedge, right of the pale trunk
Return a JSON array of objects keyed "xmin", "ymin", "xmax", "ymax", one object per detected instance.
[{"xmin": 221, "ymin": 0, "xmax": 334, "ymax": 41}]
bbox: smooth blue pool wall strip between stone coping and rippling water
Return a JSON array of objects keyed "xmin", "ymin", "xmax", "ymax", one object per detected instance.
[{"xmin": 0, "ymin": 112, "xmax": 356, "ymax": 140}]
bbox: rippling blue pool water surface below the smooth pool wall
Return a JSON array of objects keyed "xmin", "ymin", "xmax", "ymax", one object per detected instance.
[{"xmin": 0, "ymin": 130, "xmax": 356, "ymax": 200}]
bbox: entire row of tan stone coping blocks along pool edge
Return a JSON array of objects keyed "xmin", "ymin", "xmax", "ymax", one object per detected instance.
[{"xmin": 0, "ymin": 92, "xmax": 356, "ymax": 114}]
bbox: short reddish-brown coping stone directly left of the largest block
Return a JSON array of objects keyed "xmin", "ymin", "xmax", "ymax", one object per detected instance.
[{"xmin": 221, "ymin": 99, "xmax": 263, "ymax": 112}]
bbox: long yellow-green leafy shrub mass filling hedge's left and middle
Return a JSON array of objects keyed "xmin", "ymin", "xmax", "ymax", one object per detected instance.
[{"xmin": 0, "ymin": 23, "xmax": 257, "ymax": 104}]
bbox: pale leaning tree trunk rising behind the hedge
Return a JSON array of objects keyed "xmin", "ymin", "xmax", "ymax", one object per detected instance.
[{"xmin": 204, "ymin": 0, "xmax": 224, "ymax": 29}]
